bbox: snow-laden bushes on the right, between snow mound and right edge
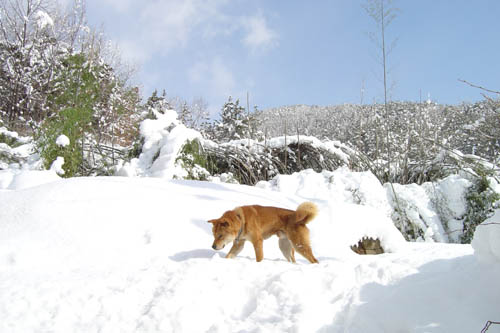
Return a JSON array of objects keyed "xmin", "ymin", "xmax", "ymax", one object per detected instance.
[{"xmin": 384, "ymin": 172, "xmax": 500, "ymax": 243}]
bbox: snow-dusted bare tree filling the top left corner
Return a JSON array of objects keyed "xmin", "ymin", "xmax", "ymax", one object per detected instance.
[{"xmin": 0, "ymin": 0, "xmax": 84, "ymax": 129}]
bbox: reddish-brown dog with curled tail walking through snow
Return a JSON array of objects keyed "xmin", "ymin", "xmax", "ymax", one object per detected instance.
[{"xmin": 208, "ymin": 202, "xmax": 318, "ymax": 263}]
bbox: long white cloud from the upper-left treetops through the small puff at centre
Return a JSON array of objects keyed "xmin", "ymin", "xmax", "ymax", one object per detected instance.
[{"xmin": 97, "ymin": 0, "xmax": 278, "ymax": 61}]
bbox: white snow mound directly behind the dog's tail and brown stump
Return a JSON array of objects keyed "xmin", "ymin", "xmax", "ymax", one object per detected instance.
[{"xmin": 256, "ymin": 168, "xmax": 405, "ymax": 252}]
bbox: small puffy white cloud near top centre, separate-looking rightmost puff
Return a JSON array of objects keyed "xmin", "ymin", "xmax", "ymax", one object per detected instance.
[{"xmin": 243, "ymin": 13, "xmax": 278, "ymax": 50}]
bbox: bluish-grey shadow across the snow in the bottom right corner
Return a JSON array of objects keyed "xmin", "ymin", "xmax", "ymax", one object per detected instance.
[{"xmin": 321, "ymin": 255, "xmax": 492, "ymax": 333}]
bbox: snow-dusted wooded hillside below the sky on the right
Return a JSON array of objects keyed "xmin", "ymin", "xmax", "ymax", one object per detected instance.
[{"xmin": 257, "ymin": 101, "xmax": 500, "ymax": 184}]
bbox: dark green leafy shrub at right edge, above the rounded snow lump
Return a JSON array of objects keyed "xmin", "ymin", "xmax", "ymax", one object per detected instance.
[{"xmin": 460, "ymin": 176, "xmax": 500, "ymax": 244}]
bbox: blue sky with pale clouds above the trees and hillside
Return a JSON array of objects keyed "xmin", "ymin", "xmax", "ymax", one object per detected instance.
[{"xmin": 87, "ymin": 0, "xmax": 500, "ymax": 113}]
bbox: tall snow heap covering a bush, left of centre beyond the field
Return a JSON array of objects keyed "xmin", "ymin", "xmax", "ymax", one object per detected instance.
[{"xmin": 116, "ymin": 110, "xmax": 202, "ymax": 179}]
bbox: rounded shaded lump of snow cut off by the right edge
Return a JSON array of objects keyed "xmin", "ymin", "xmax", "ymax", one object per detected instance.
[{"xmin": 471, "ymin": 209, "xmax": 500, "ymax": 265}]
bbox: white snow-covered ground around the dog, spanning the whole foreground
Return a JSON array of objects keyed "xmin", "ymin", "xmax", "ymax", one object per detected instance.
[{"xmin": 0, "ymin": 171, "xmax": 500, "ymax": 333}]
